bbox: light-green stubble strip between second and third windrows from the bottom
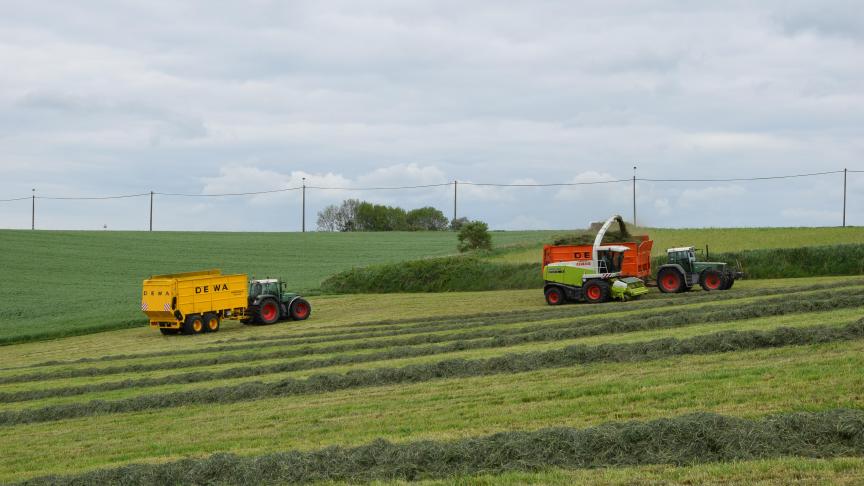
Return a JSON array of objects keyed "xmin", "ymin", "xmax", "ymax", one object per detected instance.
[{"xmin": 0, "ymin": 309, "xmax": 860, "ymax": 410}]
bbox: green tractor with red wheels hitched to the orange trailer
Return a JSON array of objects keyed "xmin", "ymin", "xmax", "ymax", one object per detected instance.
[{"xmin": 657, "ymin": 246, "xmax": 744, "ymax": 294}]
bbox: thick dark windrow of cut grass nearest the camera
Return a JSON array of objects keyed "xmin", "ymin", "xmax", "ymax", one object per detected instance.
[{"xmin": 22, "ymin": 409, "xmax": 864, "ymax": 486}]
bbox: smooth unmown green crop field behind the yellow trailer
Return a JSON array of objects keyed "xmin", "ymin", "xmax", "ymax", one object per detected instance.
[{"xmin": 0, "ymin": 230, "xmax": 543, "ymax": 344}]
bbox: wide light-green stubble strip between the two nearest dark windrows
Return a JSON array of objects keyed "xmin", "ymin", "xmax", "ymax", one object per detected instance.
[{"xmin": 0, "ymin": 340, "xmax": 864, "ymax": 481}]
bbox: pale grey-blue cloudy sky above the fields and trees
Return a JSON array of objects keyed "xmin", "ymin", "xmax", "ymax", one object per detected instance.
[{"xmin": 0, "ymin": 0, "xmax": 864, "ymax": 231}]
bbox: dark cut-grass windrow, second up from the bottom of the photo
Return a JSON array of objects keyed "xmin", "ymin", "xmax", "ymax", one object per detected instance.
[{"xmin": 0, "ymin": 319, "xmax": 864, "ymax": 425}]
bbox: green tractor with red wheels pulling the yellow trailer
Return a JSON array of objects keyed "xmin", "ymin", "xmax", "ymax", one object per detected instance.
[{"xmin": 241, "ymin": 278, "xmax": 312, "ymax": 324}]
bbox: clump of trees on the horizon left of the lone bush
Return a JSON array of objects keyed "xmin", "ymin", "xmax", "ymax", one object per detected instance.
[{"xmin": 318, "ymin": 199, "xmax": 452, "ymax": 231}]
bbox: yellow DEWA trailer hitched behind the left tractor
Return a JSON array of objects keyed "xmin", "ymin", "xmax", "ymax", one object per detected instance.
[{"xmin": 141, "ymin": 270, "xmax": 249, "ymax": 334}]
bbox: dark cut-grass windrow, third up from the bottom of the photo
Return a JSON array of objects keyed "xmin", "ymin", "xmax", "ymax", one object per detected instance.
[{"xmin": 0, "ymin": 296, "xmax": 864, "ymax": 403}]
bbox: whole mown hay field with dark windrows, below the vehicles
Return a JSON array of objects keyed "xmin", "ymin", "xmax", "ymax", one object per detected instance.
[{"xmin": 0, "ymin": 277, "xmax": 864, "ymax": 484}]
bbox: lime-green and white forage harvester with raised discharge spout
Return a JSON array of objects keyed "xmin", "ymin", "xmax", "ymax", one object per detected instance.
[{"xmin": 543, "ymin": 216, "xmax": 648, "ymax": 305}]
